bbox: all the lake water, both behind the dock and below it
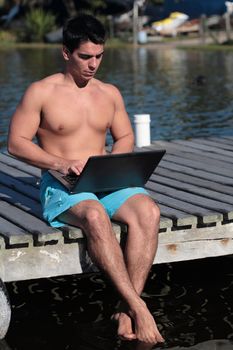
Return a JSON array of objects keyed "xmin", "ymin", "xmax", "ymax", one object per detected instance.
[{"xmin": 0, "ymin": 47, "xmax": 233, "ymax": 350}]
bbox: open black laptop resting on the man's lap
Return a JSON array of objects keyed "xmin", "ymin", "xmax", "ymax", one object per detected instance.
[{"xmin": 49, "ymin": 150, "xmax": 166, "ymax": 193}]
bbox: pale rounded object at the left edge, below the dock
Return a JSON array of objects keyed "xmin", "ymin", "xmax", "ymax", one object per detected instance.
[{"xmin": 0, "ymin": 279, "xmax": 11, "ymax": 339}]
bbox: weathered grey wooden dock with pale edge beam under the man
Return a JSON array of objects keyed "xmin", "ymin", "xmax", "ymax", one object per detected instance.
[{"xmin": 0, "ymin": 137, "xmax": 233, "ymax": 339}]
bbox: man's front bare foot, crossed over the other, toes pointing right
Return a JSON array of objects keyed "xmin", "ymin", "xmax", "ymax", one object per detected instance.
[{"xmin": 129, "ymin": 300, "xmax": 164, "ymax": 344}]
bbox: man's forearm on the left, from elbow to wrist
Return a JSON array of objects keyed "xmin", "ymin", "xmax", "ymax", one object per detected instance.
[{"xmin": 8, "ymin": 139, "xmax": 66, "ymax": 170}]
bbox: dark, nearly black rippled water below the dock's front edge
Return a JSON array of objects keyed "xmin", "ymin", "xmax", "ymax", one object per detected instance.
[{"xmin": 0, "ymin": 257, "xmax": 233, "ymax": 350}]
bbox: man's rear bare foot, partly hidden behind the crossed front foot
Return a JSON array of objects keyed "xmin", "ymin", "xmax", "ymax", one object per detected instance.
[{"xmin": 112, "ymin": 312, "xmax": 136, "ymax": 340}]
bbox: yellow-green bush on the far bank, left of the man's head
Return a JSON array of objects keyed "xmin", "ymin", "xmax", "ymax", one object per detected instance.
[{"xmin": 25, "ymin": 8, "xmax": 55, "ymax": 42}]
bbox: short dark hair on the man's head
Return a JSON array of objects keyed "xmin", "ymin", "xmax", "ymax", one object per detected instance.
[{"xmin": 63, "ymin": 14, "xmax": 106, "ymax": 53}]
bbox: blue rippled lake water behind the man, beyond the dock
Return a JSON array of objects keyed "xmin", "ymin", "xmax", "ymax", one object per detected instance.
[{"xmin": 0, "ymin": 47, "xmax": 233, "ymax": 147}]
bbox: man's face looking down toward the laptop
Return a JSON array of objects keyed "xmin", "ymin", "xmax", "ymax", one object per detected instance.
[{"xmin": 63, "ymin": 41, "xmax": 104, "ymax": 81}]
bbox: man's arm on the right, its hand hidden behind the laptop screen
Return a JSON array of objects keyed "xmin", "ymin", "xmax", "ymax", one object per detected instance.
[{"xmin": 110, "ymin": 87, "xmax": 134, "ymax": 153}]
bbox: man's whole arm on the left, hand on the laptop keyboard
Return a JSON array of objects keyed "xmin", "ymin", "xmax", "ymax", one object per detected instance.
[{"xmin": 8, "ymin": 82, "xmax": 83, "ymax": 174}]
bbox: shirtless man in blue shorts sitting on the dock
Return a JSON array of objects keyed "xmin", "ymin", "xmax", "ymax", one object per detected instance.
[{"xmin": 8, "ymin": 15, "xmax": 163, "ymax": 344}]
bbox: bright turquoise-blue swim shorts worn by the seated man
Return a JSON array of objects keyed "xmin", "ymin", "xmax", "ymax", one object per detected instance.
[{"xmin": 40, "ymin": 172, "xmax": 149, "ymax": 227}]
